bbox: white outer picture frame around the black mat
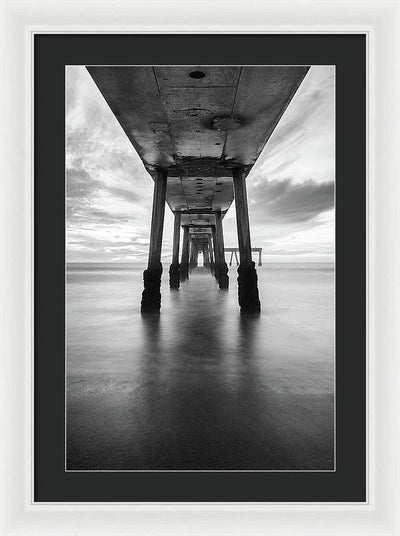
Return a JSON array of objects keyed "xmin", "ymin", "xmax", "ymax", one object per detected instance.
[{"xmin": 0, "ymin": 0, "xmax": 400, "ymax": 536}]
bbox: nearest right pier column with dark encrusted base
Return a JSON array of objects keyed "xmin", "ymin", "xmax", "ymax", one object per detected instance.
[{"xmin": 233, "ymin": 168, "xmax": 261, "ymax": 313}]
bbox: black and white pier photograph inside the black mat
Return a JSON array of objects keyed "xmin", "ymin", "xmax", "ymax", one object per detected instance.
[{"xmin": 65, "ymin": 65, "xmax": 336, "ymax": 472}]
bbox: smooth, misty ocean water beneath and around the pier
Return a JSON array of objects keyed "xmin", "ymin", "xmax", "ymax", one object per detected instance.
[{"xmin": 66, "ymin": 263, "xmax": 335, "ymax": 471}]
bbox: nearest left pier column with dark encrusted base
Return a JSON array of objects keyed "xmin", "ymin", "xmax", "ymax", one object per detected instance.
[{"xmin": 141, "ymin": 169, "xmax": 167, "ymax": 313}]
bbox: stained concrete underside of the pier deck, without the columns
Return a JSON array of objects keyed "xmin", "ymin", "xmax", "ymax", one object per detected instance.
[{"xmin": 87, "ymin": 65, "xmax": 308, "ymax": 226}]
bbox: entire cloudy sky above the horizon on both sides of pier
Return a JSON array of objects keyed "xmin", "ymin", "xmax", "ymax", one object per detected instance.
[{"xmin": 66, "ymin": 66, "xmax": 335, "ymax": 264}]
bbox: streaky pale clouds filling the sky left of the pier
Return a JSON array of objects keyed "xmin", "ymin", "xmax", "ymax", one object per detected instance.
[{"xmin": 66, "ymin": 66, "xmax": 157, "ymax": 261}]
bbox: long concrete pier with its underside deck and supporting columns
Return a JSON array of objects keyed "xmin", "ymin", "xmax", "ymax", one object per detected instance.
[{"xmin": 87, "ymin": 66, "xmax": 309, "ymax": 313}]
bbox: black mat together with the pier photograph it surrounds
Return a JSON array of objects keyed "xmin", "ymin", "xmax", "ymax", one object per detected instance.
[{"xmin": 34, "ymin": 34, "xmax": 366, "ymax": 502}]
